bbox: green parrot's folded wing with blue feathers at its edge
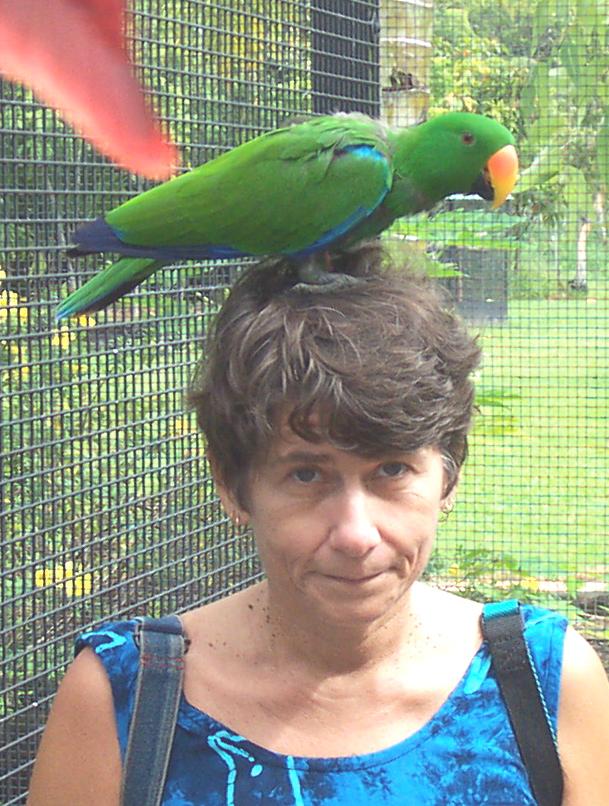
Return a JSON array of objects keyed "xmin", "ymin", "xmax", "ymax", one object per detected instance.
[{"xmin": 105, "ymin": 115, "xmax": 392, "ymax": 255}]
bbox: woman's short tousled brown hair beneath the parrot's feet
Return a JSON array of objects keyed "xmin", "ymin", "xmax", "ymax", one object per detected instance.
[{"xmin": 187, "ymin": 243, "xmax": 480, "ymax": 507}]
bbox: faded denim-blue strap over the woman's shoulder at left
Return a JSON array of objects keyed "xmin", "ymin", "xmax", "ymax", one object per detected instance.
[{"xmin": 121, "ymin": 616, "xmax": 185, "ymax": 806}]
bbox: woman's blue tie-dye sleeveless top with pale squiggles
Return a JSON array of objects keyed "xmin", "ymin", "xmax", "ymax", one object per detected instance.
[{"xmin": 77, "ymin": 606, "xmax": 566, "ymax": 806}]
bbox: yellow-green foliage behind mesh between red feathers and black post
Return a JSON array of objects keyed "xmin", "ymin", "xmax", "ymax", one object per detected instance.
[{"xmin": 134, "ymin": 0, "xmax": 311, "ymax": 158}]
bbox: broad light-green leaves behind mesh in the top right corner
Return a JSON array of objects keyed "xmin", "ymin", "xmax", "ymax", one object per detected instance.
[{"xmin": 518, "ymin": 0, "xmax": 609, "ymax": 220}]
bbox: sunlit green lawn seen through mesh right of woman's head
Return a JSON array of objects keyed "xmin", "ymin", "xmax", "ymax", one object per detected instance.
[{"xmin": 438, "ymin": 290, "xmax": 609, "ymax": 586}]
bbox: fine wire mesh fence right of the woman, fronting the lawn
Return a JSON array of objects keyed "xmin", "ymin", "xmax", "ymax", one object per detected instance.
[{"xmin": 413, "ymin": 0, "xmax": 609, "ymax": 640}]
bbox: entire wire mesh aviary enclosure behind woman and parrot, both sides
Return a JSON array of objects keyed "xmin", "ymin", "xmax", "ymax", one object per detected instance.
[{"xmin": 0, "ymin": 0, "xmax": 609, "ymax": 804}]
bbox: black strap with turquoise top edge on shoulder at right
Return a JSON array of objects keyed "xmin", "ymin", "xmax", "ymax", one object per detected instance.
[{"xmin": 482, "ymin": 600, "xmax": 563, "ymax": 806}]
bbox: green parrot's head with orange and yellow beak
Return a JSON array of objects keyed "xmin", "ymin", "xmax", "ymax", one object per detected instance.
[{"xmin": 394, "ymin": 112, "xmax": 518, "ymax": 213}]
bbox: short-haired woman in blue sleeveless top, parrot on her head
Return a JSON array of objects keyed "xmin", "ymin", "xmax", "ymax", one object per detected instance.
[{"xmin": 29, "ymin": 247, "xmax": 609, "ymax": 806}]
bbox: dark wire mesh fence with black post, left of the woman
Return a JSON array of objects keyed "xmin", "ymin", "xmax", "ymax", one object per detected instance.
[{"xmin": 0, "ymin": 0, "xmax": 379, "ymax": 803}]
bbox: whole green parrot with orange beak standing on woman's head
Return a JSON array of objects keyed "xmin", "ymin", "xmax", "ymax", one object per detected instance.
[{"xmin": 57, "ymin": 112, "xmax": 518, "ymax": 319}]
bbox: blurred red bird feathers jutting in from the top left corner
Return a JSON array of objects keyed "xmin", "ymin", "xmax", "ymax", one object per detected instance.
[{"xmin": 0, "ymin": 0, "xmax": 178, "ymax": 179}]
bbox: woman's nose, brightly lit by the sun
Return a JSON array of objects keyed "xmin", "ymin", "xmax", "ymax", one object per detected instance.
[{"xmin": 329, "ymin": 489, "xmax": 381, "ymax": 557}]
